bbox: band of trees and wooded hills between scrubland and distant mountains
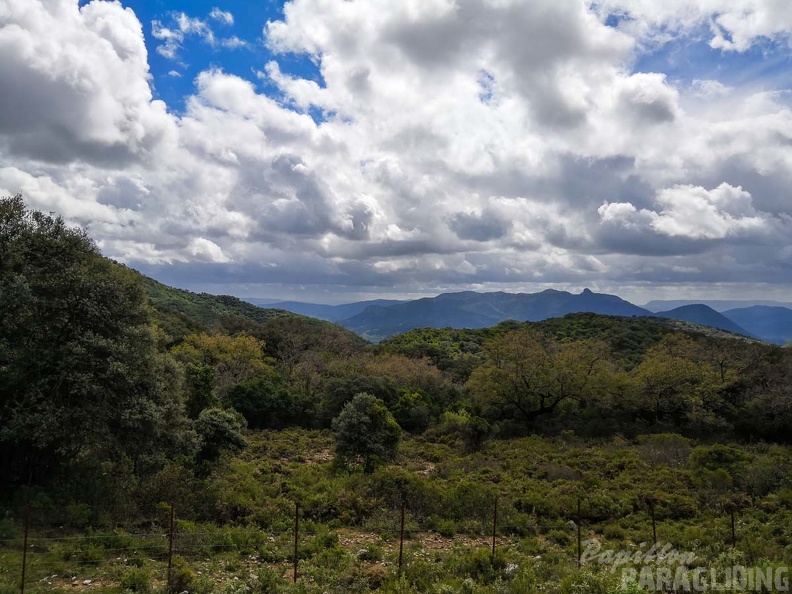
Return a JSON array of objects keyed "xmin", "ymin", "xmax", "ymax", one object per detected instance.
[{"xmin": 0, "ymin": 196, "xmax": 792, "ymax": 501}]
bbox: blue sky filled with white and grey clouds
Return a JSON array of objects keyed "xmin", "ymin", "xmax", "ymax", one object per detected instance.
[{"xmin": 0, "ymin": 0, "xmax": 792, "ymax": 303}]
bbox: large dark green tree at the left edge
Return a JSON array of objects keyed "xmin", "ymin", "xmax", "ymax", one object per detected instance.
[{"xmin": 0, "ymin": 196, "xmax": 190, "ymax": 485}]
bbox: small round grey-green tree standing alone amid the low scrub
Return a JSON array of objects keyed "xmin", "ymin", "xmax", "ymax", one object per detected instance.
[{"xmin": 333, "ymin": 393, "xmax": 401, "ymax": 472}]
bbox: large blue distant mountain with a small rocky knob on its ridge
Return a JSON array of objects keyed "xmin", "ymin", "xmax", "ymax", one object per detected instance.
[{"xmin": 339, "ymin": 289, "xmax": 651, "ymax": 340}]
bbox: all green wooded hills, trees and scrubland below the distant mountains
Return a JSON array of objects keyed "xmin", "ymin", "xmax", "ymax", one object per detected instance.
[{"xmin": 0, "ymin": 196, "xmax": 792, "ymax": 594}]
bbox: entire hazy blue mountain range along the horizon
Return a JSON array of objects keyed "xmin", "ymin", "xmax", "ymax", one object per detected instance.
[{"xmin": 247, "ymin": 289, "xmax": 792, "ymax": 344}]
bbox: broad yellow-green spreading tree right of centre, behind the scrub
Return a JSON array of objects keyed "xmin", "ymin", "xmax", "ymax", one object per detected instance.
[{"xmin": 467, "ymin": 329, "xmax": 611, "ymax": 429}]
